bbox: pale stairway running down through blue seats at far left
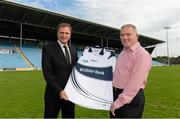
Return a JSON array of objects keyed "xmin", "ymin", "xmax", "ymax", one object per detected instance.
[{"xmin": 15, "ymin": 45, "xmax": 36, "ymax": 69}]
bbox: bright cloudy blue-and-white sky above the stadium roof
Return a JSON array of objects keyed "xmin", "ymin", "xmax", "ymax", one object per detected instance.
[{"xmin": 8, "ymin": 0, "xmax": 180, "ymax": 57}]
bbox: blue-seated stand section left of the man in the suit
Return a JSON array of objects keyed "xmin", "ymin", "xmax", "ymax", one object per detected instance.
[{"xmin": 0, "ymin": 39, "xmax": 42, "ymax": 70}]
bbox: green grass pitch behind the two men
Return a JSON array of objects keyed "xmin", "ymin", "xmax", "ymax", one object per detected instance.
[{"xmin": 0, "ymin": 66, "xmax": 180, "ymax": 118}]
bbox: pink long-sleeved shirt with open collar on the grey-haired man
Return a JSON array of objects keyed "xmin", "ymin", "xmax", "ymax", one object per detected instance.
[{"xmin": 113, "ymin": 42, "xmax": 152, "ymax": 109}]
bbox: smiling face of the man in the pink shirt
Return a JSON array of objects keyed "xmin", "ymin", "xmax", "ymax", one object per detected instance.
[{"xmin": 120, "ymin": 27, "xmax": 138, "ymax": 48}]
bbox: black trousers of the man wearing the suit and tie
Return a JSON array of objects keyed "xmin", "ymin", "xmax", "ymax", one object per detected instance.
[{"xmin": 44, "ymin": 100, "xmax": 75, "ymax": 118}]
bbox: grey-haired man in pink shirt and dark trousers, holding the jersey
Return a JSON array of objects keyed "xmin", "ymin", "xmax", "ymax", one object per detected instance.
[{"xmin": 110, "ymin": 24, "xmax": 151, "ymax": 118}]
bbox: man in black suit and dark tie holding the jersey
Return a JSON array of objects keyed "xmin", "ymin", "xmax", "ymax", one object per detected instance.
[{"xmin": 42, "ymin": 23, "xmax": 77, "ymax": 118}]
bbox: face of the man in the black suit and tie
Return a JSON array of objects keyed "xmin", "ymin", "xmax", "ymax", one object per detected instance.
[{"xmin": 57, "ymin": 27, "xmax": 71, "ymax": 44}]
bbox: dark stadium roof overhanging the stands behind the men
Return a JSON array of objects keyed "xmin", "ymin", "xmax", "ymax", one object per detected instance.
[{"xmin": 0, "ymin": 0, "xmax": 164, "ymax": 48}]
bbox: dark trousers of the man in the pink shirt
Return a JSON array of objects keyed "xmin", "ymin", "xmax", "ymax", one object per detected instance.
[{"xmin": 110, "ymin": 88, "xmax": 145, "ymax": 118}]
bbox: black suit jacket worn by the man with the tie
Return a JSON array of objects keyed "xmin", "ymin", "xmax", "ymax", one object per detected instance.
[{"xmin": 42, "ymin": 42, "xmax": 78, "ymax": 101}]
